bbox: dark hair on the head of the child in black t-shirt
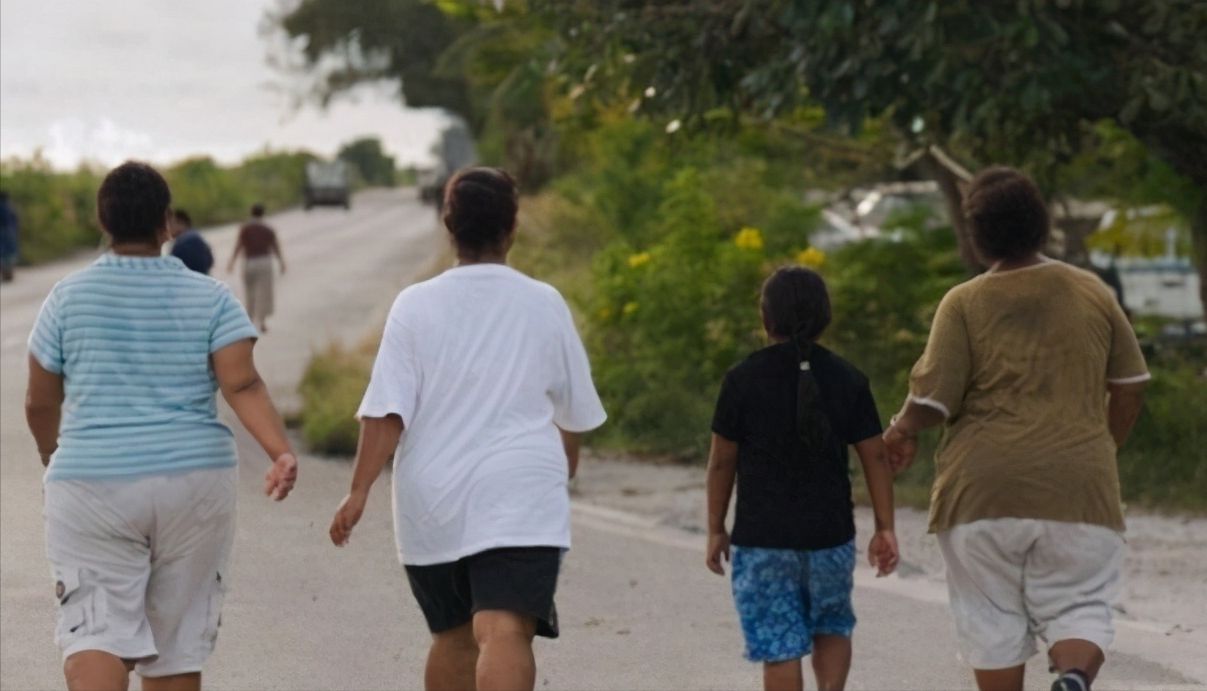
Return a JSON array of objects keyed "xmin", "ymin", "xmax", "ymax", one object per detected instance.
[{"xmin": 762, "ymin": 266, "xmax": 832, "ymax": 343}]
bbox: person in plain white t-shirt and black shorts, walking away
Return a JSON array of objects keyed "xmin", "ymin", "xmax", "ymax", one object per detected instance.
[{"xmin": 331, "ymin": 168, "xmax": 606, "ymax": 691}]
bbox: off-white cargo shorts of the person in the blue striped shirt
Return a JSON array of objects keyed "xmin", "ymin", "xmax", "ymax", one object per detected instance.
[{"xmin": 43, "ymin": 468, "xmax": 238, "ymax": 678}]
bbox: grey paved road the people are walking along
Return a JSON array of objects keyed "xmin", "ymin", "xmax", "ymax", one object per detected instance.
[{"xmin": 0, "ymin": 186, "xmax": 1207, "ymax": 690}]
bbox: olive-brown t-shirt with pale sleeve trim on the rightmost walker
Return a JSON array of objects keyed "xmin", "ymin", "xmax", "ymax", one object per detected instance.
[{"xmin": 910, "ymin": 257, "xmax": 1149, "ymax": 533}]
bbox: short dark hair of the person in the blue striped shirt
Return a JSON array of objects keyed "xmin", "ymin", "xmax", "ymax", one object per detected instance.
[{"xmin": 97, "ymin": 161, "xmax": 171, "ymax": 243}]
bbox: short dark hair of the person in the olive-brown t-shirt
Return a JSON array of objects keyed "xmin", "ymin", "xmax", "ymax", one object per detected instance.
[{"xmin": 964, "ymin": 166, "xmax": 1050, "ymax": 261}]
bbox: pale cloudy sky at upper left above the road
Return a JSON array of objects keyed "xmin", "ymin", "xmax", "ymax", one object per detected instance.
[{"xmin": 0, "ymin": 0, "xmax": 453, "ymax": 168}]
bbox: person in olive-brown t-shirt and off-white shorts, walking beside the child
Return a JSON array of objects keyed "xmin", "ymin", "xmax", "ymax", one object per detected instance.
[{"xmin": 885, "ymin": 168, "xmax": 1149, "ymax": 691}]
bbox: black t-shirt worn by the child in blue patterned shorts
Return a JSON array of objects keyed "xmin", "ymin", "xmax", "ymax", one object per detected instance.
[{"xmin": 712, "ymin": 343, "xmax": 882, "ymax": 550}]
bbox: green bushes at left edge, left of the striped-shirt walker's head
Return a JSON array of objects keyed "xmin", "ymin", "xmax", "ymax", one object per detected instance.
[{"xmin": 0, "ymin": 156, "xmax": 101, "ymax": 263}]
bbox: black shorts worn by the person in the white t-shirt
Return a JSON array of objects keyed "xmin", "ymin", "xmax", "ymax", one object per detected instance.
[{"xmin": 406, "ymin": 547, "xmax": 561, "ymax": 638}]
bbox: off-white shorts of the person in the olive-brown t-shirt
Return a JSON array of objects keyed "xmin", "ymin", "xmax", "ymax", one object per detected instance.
[{"xmin": 938, "ymin": 518, "xmax": 1124, "ymax": 669}]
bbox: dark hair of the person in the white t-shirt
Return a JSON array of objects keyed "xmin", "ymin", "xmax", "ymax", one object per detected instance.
[{"xmin": 444, "ymin": 168, "xmax": 519, "ymax": 254}]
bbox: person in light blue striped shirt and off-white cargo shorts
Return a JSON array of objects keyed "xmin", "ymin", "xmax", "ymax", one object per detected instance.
[{"xmin": 25, "ymin": 163, "xmax": 297, "ymax": 691}]
